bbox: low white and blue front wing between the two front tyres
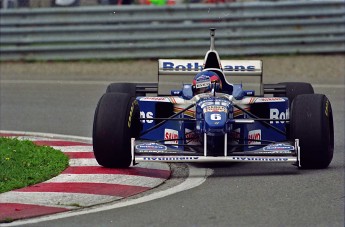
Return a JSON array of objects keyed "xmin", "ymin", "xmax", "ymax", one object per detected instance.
[{"xmin": 131, "ymin": 134, "xmax": 301, "ymax": 167}]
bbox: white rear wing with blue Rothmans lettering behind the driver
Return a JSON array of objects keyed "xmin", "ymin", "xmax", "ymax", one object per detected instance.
[{"xmin": 158, "ymin": 59, "xmax": 263, "ymax": 94}]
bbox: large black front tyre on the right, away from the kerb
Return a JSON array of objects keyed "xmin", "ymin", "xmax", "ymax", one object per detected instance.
[{"xmin": 290, "ymin": 94, "xmax": 334, "ymax": 169}]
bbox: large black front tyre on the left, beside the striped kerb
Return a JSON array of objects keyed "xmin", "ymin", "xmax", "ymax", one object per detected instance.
[{"xmin": 92, "ymin": 93, "xmax": 140, "ymax": 168}]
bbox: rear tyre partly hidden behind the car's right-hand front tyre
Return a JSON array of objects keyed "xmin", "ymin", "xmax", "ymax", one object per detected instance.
[{"xmin": 275, "ymin": 82, "xmax": 314, "ymax": 107}]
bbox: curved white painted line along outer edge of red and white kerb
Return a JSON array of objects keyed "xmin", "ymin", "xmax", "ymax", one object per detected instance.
[{"xmin": 3, "ymin": 165, "xmax": 213, "ymax": 226}]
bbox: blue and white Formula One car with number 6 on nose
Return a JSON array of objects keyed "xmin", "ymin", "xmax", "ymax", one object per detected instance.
[{"xmin": 93, "ymin": 29, "xmax": 334, "ymax": 168}]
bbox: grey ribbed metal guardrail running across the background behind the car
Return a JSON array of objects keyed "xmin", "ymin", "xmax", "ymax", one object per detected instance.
[{"xmin": 0, "ymin": 0, "xmax": 345, "ymax": 61}]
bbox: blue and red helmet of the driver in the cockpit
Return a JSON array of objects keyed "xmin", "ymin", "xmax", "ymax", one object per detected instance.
[{"xmin": 192, "ymin": 71, "xmax": 222, "ymax": 95}]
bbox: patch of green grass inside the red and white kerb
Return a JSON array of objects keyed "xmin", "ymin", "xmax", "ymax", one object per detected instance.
[{"xmin": 0, "ymin": 137, "xmax": 68, "ymax": 193}]
